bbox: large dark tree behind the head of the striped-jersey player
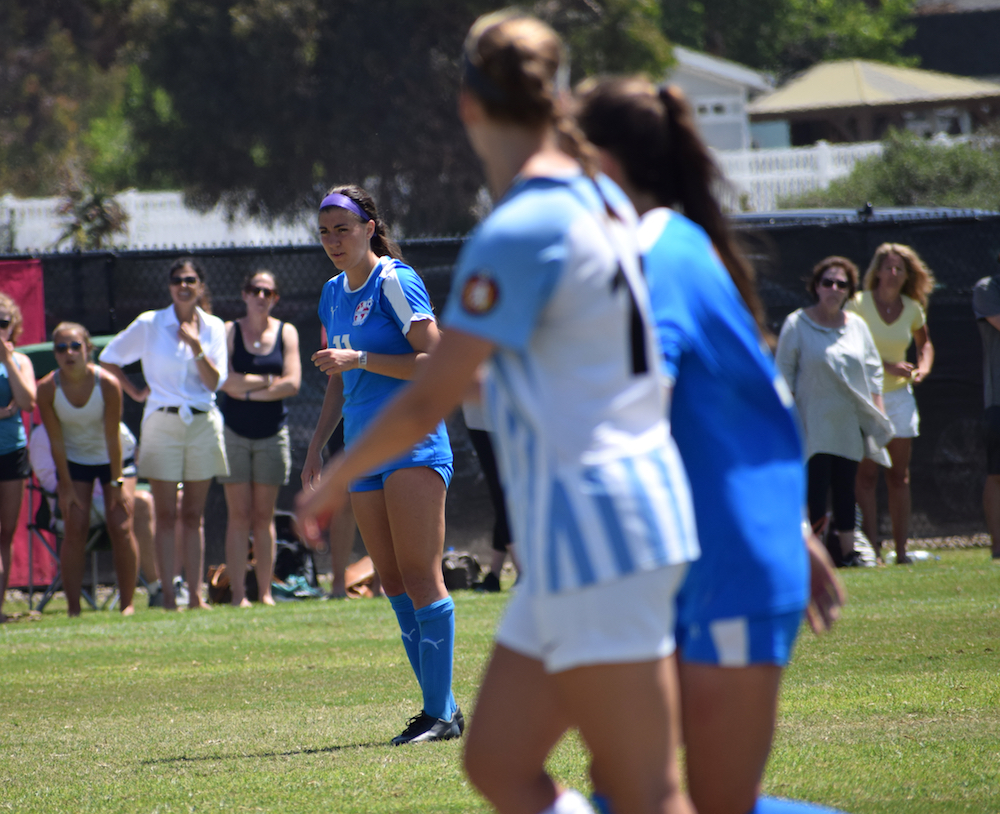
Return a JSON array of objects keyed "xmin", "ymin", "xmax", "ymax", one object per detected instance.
[{"xmin": 128, "ymin": 0, "xmax": 670, "ymax": 235}]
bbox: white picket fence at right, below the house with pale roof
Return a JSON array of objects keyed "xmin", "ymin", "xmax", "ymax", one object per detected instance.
[{"xmin": 714, "ymin": 141, "xmax": 882, "ymax": 212}]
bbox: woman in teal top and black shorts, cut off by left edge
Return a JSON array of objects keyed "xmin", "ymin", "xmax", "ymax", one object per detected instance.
[{"xmin": 0, "ymin": 294, "xmax": 35, "ymax": 623}]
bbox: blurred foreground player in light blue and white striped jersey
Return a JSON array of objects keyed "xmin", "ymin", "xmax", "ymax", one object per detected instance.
[{"xmin": 299, "ymin": 12, "xmax": 698, "ymax": 814}]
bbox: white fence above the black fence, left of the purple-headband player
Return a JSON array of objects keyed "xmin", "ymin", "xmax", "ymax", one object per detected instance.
[{"xmin": 0, "ymin": 190, "xmax": 317, "ymax": 252}]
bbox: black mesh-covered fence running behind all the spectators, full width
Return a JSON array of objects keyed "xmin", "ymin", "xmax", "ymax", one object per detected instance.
[{"xmin": 3, "ymin": 211, "xmax": 1000, "ymax": 562}]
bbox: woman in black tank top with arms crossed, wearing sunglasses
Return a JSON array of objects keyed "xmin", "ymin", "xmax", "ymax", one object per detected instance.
[{"xmin": 219, "ymin": 269, "xmax": 302, "ymax": 608}]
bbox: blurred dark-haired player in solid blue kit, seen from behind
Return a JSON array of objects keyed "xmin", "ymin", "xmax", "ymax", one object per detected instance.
[{"xmin": 577, "ymin": 78, "xmax": 843, "ymax": 814}]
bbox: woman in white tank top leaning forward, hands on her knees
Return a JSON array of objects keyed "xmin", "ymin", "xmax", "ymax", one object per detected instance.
[{"xmin": 38, "ymin": 322, "xmax": 139, "ymax": 616}]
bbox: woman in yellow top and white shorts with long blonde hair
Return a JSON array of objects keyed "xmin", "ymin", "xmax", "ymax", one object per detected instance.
[{"xmin": 849, "ymin": 243, "xmax": 934, "ymax": 565}]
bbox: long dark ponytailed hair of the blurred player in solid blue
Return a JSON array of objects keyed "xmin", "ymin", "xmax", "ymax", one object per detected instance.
[{"xmin": 578, "ymin": 77, "xmax": 773, "ymax": 342}]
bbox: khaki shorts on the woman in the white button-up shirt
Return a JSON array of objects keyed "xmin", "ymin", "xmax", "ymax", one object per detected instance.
[{"xmin": 139, "ymin": 408, "xmax": 229, "ymax": 483}]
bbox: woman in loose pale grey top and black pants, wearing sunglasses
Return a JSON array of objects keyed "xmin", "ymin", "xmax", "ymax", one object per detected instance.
[{"xmin": 776, "ymin": 257, "xmax": 892, "ymax": 566}]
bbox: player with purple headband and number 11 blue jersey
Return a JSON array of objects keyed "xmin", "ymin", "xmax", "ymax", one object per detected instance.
[{"xmin": 302, "ymin": 186, "xmax": 465, "ymax": 745}]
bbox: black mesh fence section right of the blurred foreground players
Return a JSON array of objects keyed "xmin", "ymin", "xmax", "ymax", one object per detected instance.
[{"xmin": 740, "ymin": 212, "xmax": 1000, "ymax": 537}]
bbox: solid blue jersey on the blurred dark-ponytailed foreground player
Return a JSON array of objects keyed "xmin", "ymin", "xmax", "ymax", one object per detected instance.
[{"xmin": 639, "ymin": 209, "xmax": 808, "ymax": 625}]
